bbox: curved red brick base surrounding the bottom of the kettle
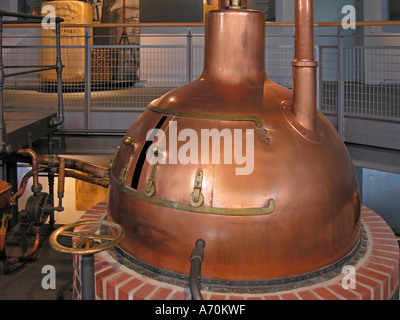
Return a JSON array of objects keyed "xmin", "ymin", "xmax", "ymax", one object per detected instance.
[{"xmin": 73, "ymin": 202, "xmax": 399, "ymax": 300}]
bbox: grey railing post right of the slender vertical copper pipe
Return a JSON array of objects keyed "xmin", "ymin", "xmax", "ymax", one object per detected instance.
[{"xmin": 337, "ymin": 27, "xmax": 345, "ymax": 140}]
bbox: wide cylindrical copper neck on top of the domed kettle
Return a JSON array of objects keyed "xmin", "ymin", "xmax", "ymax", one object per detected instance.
[{"xmin": 201, "ymin": 10, "xmax": 266, "ymax": 85}]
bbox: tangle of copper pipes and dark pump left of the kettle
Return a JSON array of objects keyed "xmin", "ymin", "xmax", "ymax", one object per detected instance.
[{"xmin": 0, "ymin": 149, "xmax": 108, "ymax": 273}]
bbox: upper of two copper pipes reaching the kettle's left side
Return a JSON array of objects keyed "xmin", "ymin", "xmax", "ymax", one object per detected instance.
[{"xmin": 38, "ymin": 155, "xmax": 108, "ymax": 178}]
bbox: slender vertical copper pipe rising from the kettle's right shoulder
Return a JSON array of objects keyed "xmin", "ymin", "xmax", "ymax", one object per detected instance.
[{"xmin": 292, "ymin": 0, "xmax": 318, "ymax": 131}]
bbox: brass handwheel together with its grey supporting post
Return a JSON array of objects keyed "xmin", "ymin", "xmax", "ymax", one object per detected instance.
[{"xmin": 49, "ymin": 220, "xmax": 125, "ymax": 300}]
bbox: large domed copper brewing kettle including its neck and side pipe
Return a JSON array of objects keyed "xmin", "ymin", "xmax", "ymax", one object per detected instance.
[{"xmin": 108, "ymin": 0, "xmax": 361, "ymax": 280}]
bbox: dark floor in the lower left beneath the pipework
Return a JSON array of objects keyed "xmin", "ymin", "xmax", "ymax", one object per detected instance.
[{"xmin": 0, "ymin": 225, "xmax": 73, "ymax": 300}]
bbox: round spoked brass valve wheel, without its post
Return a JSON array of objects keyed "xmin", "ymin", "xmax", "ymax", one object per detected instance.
[{"xmin": 49, "ymin": 220, "xmax": 125, "ymax": 255}]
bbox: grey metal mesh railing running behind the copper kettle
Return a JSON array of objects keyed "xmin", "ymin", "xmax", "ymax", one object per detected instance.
[{"xmin": 3, "ymin": 22, "xmax": 400, "ymax": 149}]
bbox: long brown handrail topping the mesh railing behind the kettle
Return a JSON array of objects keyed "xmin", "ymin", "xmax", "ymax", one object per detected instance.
[{"xmin": 3, "ymin": 21, "xmax": 400, "ymax": 28}]
